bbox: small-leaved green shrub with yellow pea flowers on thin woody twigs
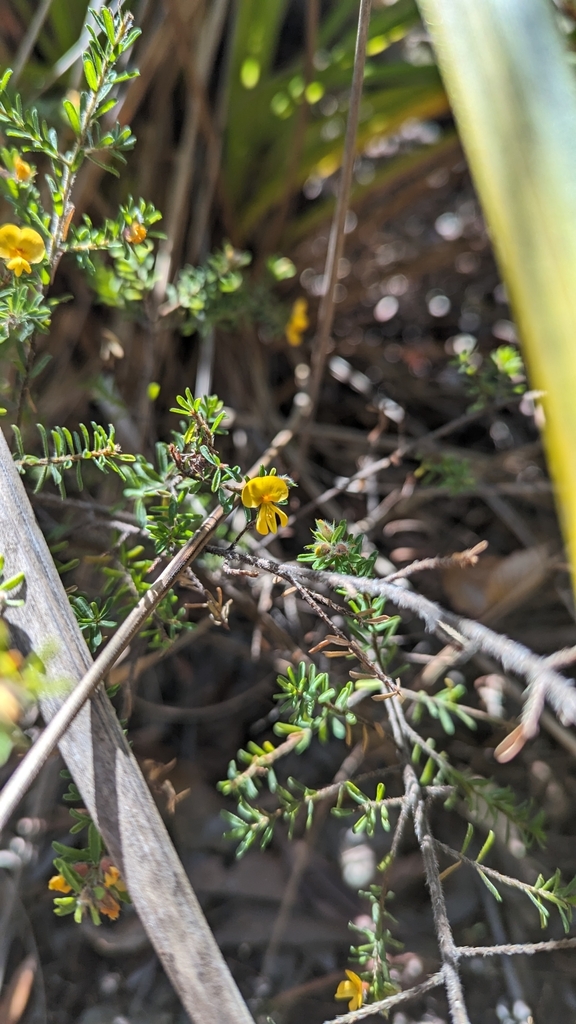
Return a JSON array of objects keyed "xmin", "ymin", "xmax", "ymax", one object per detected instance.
[{"xmin": 0, "ymin": 3, "xmax": 576, "ymax": 1012}]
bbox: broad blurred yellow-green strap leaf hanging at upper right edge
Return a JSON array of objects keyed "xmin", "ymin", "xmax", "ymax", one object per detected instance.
[{"xmin": 414, "ymin": 0, "xmax": 576, "ymax": 593}]
